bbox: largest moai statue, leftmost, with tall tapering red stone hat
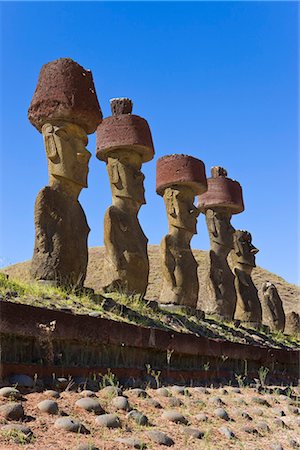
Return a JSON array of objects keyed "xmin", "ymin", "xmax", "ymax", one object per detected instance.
[{"xmin": 28, "ymin": 58, "xmax": 102, "ymax": 288}]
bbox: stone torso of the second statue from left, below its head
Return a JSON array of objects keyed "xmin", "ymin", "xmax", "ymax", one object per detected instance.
[{"xmin": 104, "ymin": 206, "xmax": 149, "ymax": 294}]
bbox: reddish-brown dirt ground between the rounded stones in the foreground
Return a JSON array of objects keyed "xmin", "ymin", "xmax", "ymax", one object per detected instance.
[{"xmin": 0, "ymin": 386, "xmax": 300, "ymax": 450}]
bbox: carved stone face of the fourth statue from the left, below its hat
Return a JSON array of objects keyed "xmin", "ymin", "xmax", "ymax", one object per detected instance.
[{"xmin": 206, "ymin": 209, "xmax": 234, "ymax": 249}]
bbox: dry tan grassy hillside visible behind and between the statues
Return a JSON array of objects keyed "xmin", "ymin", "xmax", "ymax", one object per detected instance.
[{"xmin": 2, "ymin": 245, "xmax": 300, "ymax": 313}]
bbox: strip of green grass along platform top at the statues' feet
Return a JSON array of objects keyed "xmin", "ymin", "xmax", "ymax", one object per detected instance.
[{"xmin": 0, "ymin": 274, "xmax": 300, "ymax": 348}]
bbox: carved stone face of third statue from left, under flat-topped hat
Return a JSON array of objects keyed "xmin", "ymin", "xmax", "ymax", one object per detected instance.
[{"xmin": 164, "ymin": 186, "xmax": 199, "ymax": 234}]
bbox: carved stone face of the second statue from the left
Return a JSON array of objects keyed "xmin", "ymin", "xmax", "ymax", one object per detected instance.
[{"xmin": 107, "ymin": 150, "xmax": 146, "ymax": 205}]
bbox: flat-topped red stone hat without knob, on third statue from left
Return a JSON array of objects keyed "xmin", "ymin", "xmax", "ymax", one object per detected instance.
[{"xmin": 156, "ymin": 155, "xmax": 207, "ymax": 195}]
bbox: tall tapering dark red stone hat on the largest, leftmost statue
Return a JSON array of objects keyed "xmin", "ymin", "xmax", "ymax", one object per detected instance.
[{"xmin": 28, "ymin": 58, "xmax": 102, "ymax": 134}]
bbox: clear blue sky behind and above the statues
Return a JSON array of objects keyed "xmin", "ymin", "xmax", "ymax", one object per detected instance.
[{"xmin": 0, "ymin": 2, "xmax": 299, "ymax": 283}]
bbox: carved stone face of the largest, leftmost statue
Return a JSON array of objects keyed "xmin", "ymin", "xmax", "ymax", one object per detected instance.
[{"xmin": 42, "ymin": 122, "xmax": 91, "ymax": 187}]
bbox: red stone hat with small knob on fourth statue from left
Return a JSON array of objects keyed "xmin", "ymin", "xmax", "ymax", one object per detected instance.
[{"xmin": 197, "ymin": 166, "xmax": 244, "ymax": 214}]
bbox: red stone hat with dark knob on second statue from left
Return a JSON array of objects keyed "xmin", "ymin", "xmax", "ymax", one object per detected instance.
[{"xmin": 96, "ymin": 98, "xmax": 154, "ymax": 162}]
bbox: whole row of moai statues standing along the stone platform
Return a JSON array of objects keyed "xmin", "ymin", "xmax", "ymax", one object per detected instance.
[{"xmin": 28, "ymin": 58, "xmax": 298, "ymax": 329}]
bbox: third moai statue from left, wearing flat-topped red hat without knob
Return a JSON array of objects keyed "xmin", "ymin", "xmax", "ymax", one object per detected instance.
[{"xmin": 156, "ymin": 155, "xmax": 207, "ymax": 308}]
